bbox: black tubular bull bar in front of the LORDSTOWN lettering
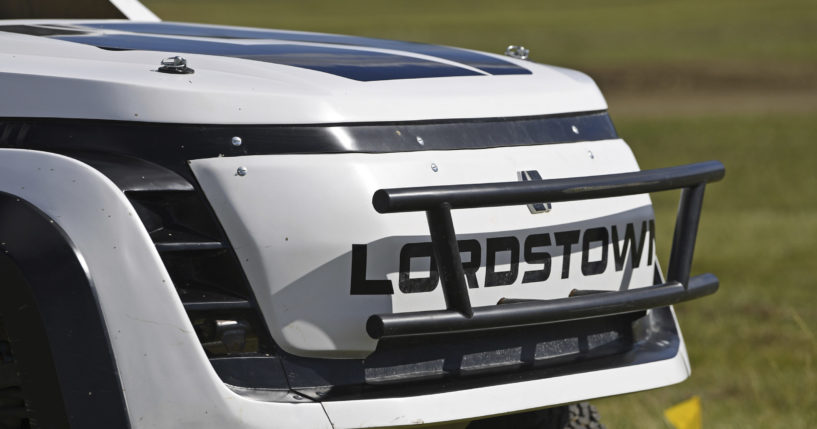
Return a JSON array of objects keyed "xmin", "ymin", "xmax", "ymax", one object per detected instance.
[{"xmin": 366, "ymin": 161, "xmax": 725, "ymax": 339}]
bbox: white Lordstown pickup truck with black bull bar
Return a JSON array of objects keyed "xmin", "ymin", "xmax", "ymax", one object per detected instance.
[{"xmin": 0, "ymin": 0, "xmax": 724, "ymax": 429}]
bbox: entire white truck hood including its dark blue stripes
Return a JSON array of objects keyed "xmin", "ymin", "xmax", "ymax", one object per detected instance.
[{"xmin": 0, "ymin": 20, "xmax": 606, "ymax": 124}]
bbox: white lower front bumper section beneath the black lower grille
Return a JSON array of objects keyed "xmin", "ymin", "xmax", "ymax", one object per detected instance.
[{"xmin": 322, "ymin": 308, "xmax": 690, "ymax": 428}]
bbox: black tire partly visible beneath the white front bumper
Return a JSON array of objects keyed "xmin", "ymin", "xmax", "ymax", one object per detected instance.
[{"xmin": 468, "ymin": 402, "xmax": 604, "ymax": 429}]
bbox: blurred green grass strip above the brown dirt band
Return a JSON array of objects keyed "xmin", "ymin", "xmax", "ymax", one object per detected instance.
[{"xmin": 145, "ymin": 0, "xmax": 817, "ymax": 64}]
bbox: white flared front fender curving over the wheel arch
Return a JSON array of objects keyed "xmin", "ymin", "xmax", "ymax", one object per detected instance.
[{"xmin": 0, "ymin": 149, "xmax": 330, "ymax": 428}]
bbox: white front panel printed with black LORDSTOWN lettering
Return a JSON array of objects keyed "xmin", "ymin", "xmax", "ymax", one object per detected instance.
[{"xmin": 191, "ymin": 140, "xmax": 654, "ymax": 357}]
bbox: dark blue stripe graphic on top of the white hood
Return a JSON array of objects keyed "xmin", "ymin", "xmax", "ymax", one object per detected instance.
[{"xmin": 0, "ymin": 22, "xmax": 531, "ymax": 82}]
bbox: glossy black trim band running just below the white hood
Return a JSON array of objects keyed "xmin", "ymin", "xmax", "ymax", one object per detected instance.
[{"xmin": 0, "ymin": 112, "xmax": 618, "ymax": 181}]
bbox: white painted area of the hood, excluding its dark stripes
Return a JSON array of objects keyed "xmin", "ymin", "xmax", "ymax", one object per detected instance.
[{"xmin": 0, "ymin": 20, "xmax": 607, "ymax": 124}]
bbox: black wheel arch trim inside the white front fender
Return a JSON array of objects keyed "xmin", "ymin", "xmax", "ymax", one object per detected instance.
[{"xmin": 0, "ymin": 192, "xmax": 130, "ymax": 428}]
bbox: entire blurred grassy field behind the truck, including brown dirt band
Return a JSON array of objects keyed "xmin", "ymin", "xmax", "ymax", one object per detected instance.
[{"xmin": 145, "ymin": 0, "xmax": 817, "ymax": 429}]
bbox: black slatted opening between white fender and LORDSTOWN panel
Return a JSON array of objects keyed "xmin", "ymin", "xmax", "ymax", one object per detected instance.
[{"xmin": 126, "ymin": 187, "xmax": 288, "ymax": 389}]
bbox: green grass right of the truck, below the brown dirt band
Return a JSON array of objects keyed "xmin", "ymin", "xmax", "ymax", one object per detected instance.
[{"xmin": 596, "ymin": 114, "xmax": 817, "ymax": 428}]
